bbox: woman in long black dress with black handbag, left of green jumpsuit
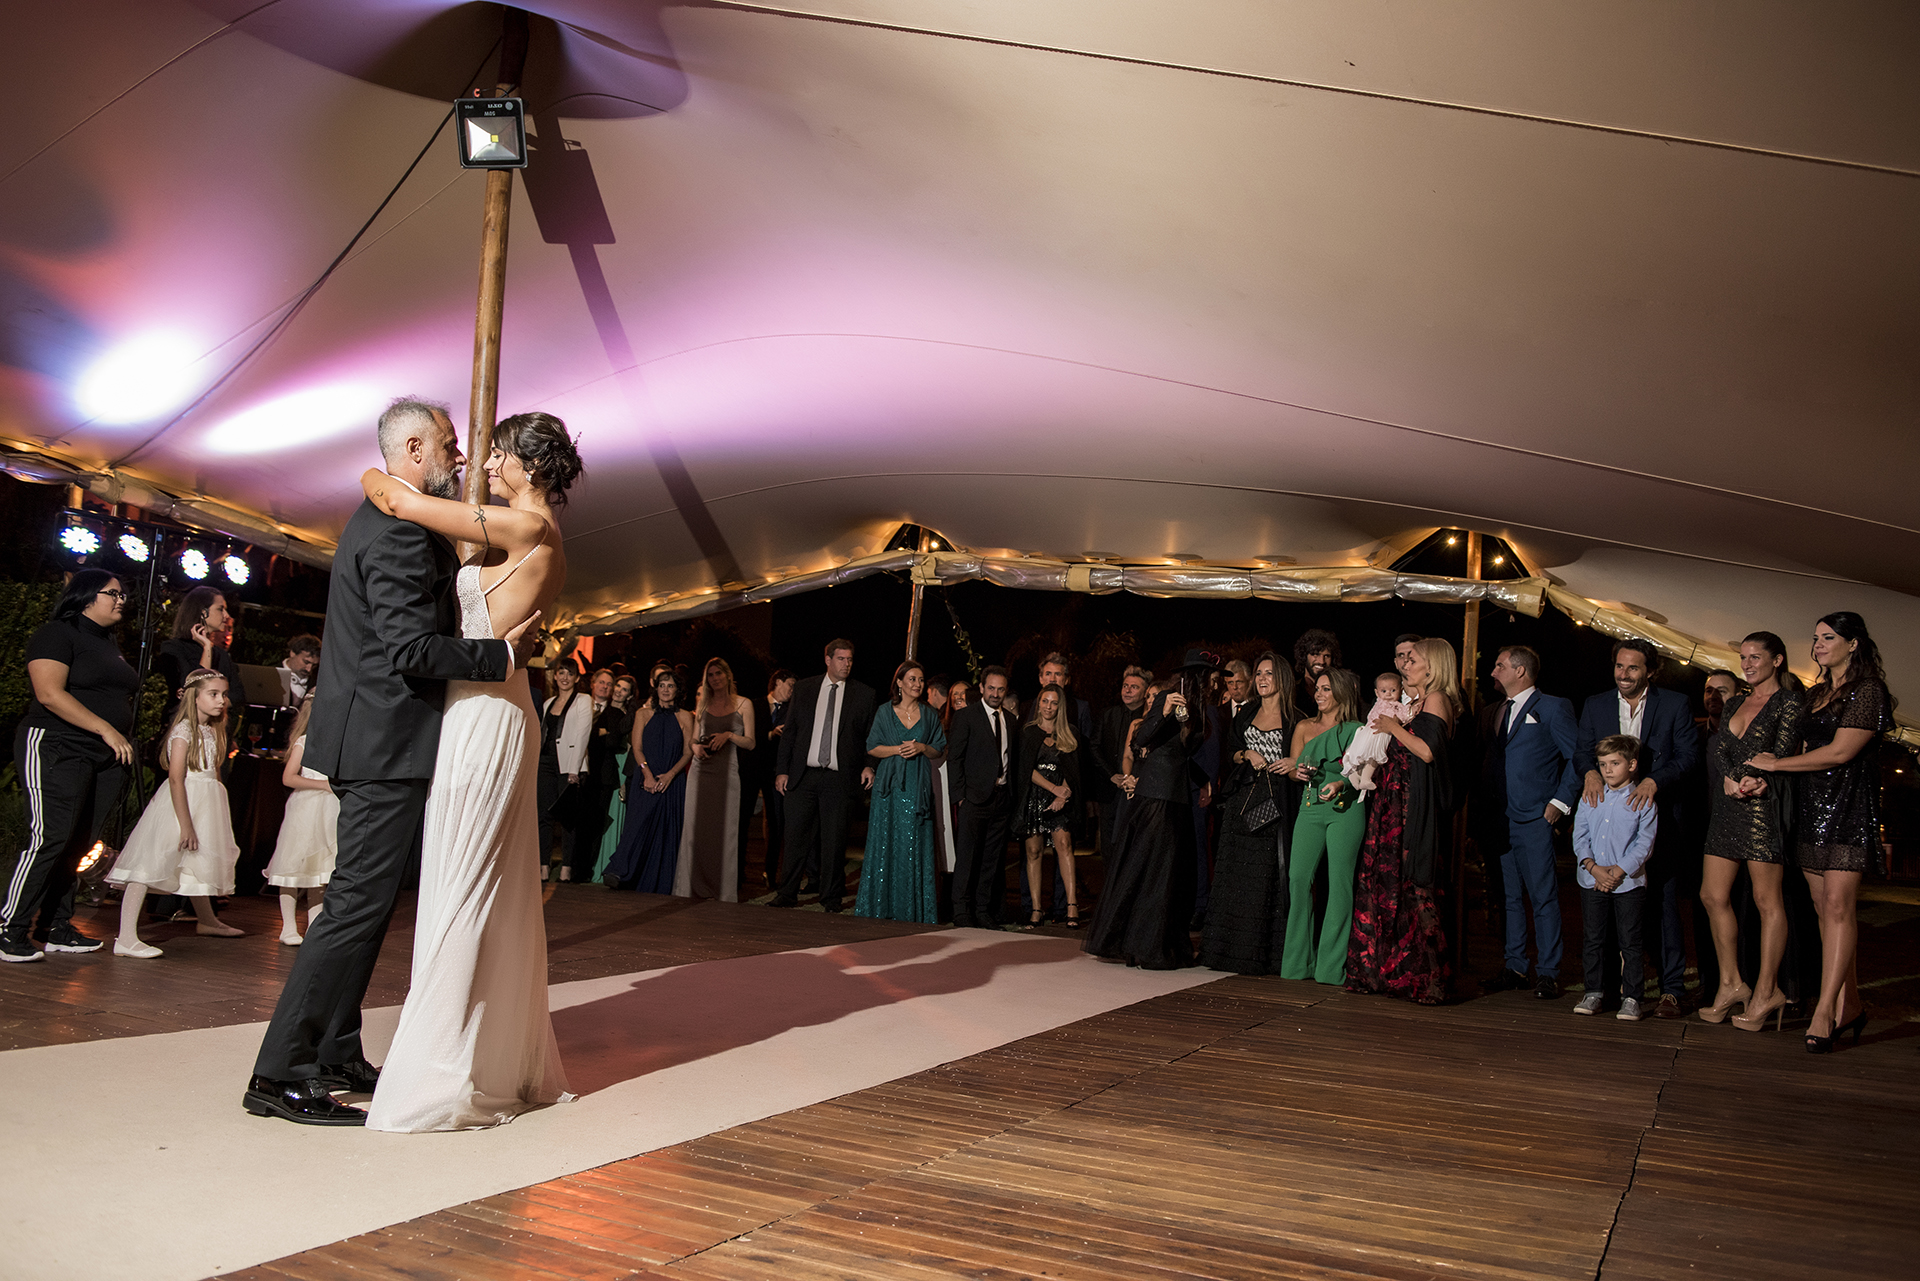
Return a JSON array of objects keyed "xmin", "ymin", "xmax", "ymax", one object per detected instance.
[{"xmin": 1200, "ymin": 649, "xmax": 1294, "ymax": 974}]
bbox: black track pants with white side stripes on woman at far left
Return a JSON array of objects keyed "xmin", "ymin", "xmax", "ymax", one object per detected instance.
[{"xmin": 0, "ymin": 724, "xmax": 127, "ymax": 939}]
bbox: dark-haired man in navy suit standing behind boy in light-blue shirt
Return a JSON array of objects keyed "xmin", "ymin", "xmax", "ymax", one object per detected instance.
[{"xmin": 1574, "ymin": 640, "xmax": 1699, "ymax": 1018}]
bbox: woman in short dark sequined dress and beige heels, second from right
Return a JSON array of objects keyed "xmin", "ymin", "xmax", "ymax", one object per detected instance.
[{"xmin": 1699, "ymin": 632, "xmax": 1807, "ymax": 1031}]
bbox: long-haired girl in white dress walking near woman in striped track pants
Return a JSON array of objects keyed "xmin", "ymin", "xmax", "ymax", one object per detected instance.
[{"xmin": 108, "ymin": 666, "xmax": 246, "ymax": 960}]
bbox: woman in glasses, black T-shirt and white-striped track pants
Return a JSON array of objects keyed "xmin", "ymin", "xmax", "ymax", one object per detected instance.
[{"xmin": 0, "ymin": 568, "xmax": 140, "ymax": 962}]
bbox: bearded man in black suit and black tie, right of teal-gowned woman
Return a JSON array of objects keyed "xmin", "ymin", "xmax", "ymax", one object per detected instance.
[{"xmin": 947, "ymin": 666, "xmax": 1018, "ymax": 930}]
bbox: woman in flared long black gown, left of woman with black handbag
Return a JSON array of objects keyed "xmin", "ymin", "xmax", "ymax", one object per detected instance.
[{"xmin": 1085, "ymin": 649, "xmax": 1219, "ymax": 970}]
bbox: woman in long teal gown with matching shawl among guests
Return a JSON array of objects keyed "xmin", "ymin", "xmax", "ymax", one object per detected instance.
[{"xmin": 852, "ymin": 659, "xmax": 947, "ymax": 926}]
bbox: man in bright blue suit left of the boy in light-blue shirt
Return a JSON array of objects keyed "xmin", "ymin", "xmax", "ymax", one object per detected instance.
[{"xmin": 1488, "ymin": 645, "xmax": 1580, "ymax": 1001}]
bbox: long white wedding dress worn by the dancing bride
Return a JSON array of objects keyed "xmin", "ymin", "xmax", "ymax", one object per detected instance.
[{"xmin": 367, "ymin": 559, "xmax": 572, "ymax": 1133}]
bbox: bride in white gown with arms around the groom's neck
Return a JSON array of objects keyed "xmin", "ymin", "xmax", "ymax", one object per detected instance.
[{"xmin": 361, "ymin": 413, "xmax": 580, "ymax": 1131}]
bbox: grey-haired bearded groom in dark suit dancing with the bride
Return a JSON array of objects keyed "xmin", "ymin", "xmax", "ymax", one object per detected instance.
[{"xmin": 242, "ymin": 398, "xmax": 540, "ymax": 1125}]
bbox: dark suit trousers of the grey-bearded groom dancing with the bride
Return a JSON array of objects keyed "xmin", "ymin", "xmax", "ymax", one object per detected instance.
[{"xmin": 253, "ymin": 778, "xmax": 426, "ymax": 1081}]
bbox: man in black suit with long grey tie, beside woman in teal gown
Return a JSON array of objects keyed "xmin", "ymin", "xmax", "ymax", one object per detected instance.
[{"xmin": 774, "ymin": 638, "xmax": 874, "ymax": 912}]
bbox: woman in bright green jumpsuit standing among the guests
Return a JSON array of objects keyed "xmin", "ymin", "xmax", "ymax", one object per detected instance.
[{"xmin": 1281, "ymin": 666, "xmax": 1367, "ymax": 985}]
